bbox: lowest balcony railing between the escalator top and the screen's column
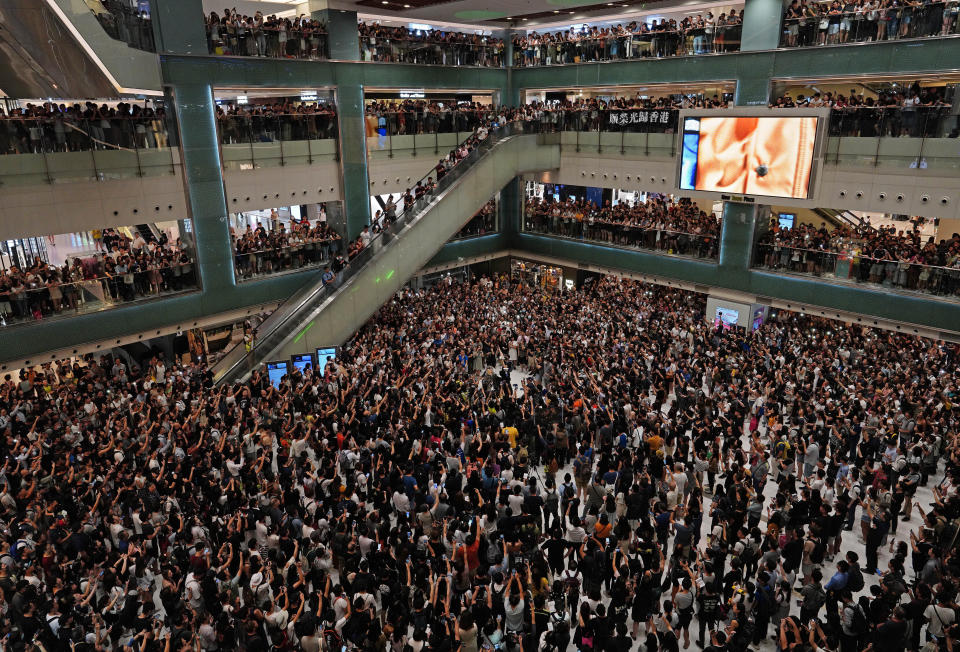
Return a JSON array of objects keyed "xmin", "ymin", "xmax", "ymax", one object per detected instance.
[{"xmin": 524, "ymin": 218, "xmax": 720, "ymax": 259}]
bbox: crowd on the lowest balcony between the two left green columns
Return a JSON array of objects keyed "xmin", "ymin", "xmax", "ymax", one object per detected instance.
[{"xmin": 231, "ymin": 219, "xmax": 341, "ymax": 279}]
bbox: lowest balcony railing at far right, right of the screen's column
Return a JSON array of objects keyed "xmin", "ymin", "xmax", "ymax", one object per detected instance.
[{"xmin": 753, "ymin": 243, "xmax": 960, "ymax": 297}]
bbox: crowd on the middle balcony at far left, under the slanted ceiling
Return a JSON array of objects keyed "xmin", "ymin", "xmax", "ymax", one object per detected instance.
[{"xmin": 0, "ymin": 101, "xmax": 170, "ymax": 154}]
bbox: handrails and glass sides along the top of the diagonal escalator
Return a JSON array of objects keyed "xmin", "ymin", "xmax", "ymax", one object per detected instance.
[{"xmin": 214, "ymin": 122, "xmax": 536, "ymax": 382}]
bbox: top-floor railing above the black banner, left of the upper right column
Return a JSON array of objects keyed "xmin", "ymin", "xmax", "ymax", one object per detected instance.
[{"xmin": 513, "ymin": 24, "xmax": 743, "ymax": 68}]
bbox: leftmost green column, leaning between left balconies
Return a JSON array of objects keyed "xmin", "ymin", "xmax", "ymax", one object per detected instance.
[{"xmin": 173, "ymin": 84, "xmax": 236, "ymax": 310}]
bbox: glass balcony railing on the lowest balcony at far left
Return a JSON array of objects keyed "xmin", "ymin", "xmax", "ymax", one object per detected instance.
[{"xmin": 0, "ymin": 262, "xmax": 197, "ymax": 326}]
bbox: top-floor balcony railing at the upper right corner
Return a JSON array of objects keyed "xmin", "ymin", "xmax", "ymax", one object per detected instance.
[{"xmin": 780, "ymin": 0, "xmax": 958, "ymax": 48}]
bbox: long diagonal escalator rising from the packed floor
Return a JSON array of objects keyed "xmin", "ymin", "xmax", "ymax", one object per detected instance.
[{"xmin": 213, "ymin": 123, "xmax": 560, "ymax": 384}]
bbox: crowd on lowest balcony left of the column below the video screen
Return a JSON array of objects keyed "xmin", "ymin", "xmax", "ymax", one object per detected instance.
[{"xmin": 524, "ymin": 195, "xmax": 720, "ymax": 258}]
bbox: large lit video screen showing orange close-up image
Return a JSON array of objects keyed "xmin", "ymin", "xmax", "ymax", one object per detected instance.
[{"xmin": 680, "ymin": 116, "xmax": 819, "ymax": 199}]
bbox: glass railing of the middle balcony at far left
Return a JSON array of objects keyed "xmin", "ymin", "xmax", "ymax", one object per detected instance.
[{"xmin": 0, "ymin": 116, "xmax": 179, "ymax": 186}]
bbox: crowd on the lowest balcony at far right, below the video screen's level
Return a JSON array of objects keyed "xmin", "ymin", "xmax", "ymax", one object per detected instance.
[{"xmin": 755, "ymin": 224, "xmax": 960, "ymax": 295}]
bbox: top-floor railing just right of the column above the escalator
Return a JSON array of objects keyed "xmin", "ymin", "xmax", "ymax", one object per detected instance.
[{"xmin": 360, "ymin": 36, "xmax": 504, "ymax": 68}]
